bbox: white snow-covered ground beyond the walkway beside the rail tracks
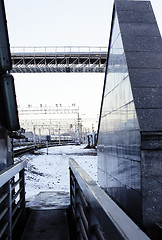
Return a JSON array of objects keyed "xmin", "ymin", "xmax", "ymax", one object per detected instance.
[{"xmin": 14, "ymin": 145, "xmax": 97, "ymax": 201}]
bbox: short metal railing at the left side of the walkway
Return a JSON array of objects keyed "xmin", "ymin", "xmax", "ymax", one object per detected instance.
[{"xmin": 0, "ymin": 161, "xmax": 26, "ymax": 240}]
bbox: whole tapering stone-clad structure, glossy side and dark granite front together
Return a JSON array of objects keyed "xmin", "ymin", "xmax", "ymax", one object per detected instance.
[{"xmin": 98, "ymin": 0, "xmax": 162, "ymax": 239}]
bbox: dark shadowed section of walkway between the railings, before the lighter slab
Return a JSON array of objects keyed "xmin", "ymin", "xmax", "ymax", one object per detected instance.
[{"xmin": 21, "ymin": 209, "xmax": 70, "ymax": 240}]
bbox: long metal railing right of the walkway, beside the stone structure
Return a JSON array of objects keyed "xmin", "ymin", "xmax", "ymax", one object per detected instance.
[{"xmin": 69, "ymin": 159, "xmax": 149, "ymax": 240}]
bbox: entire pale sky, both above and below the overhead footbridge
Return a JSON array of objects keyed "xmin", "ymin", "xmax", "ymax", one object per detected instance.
[{"xmin": 4, "ymin": 0, "xmax": 162, "ymax": 131}]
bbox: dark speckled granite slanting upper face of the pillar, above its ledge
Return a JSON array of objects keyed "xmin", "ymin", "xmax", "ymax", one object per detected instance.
[{"xmin": 114, "ymin": 0, "xmax": 162, "ymax": 132}]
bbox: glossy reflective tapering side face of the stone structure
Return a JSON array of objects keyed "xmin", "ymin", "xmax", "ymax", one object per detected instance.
[{"xmin": 98, "ymin": 9, "xmax": 141, "ymax": 221}]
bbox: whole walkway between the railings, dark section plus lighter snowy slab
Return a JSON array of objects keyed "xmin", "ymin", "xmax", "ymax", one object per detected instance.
[{"xmin": 21, "ymin": 192, "xmax": 70, "ymax": 240}]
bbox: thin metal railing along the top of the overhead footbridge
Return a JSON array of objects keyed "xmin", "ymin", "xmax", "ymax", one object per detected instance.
[{"xmin": 10, "ymin": 46, "xmax": 107, "ymax": 54}]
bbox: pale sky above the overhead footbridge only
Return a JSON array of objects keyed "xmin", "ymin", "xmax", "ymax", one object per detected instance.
[{"xmin": 5, "ymin": 0, "xmax": 162, "ymax": 46}]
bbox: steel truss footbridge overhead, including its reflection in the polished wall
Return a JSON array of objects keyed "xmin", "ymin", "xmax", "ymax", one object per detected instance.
[{"xmin": 11, "ymin": 47, "xmax": 124, "ymax": 73}]
